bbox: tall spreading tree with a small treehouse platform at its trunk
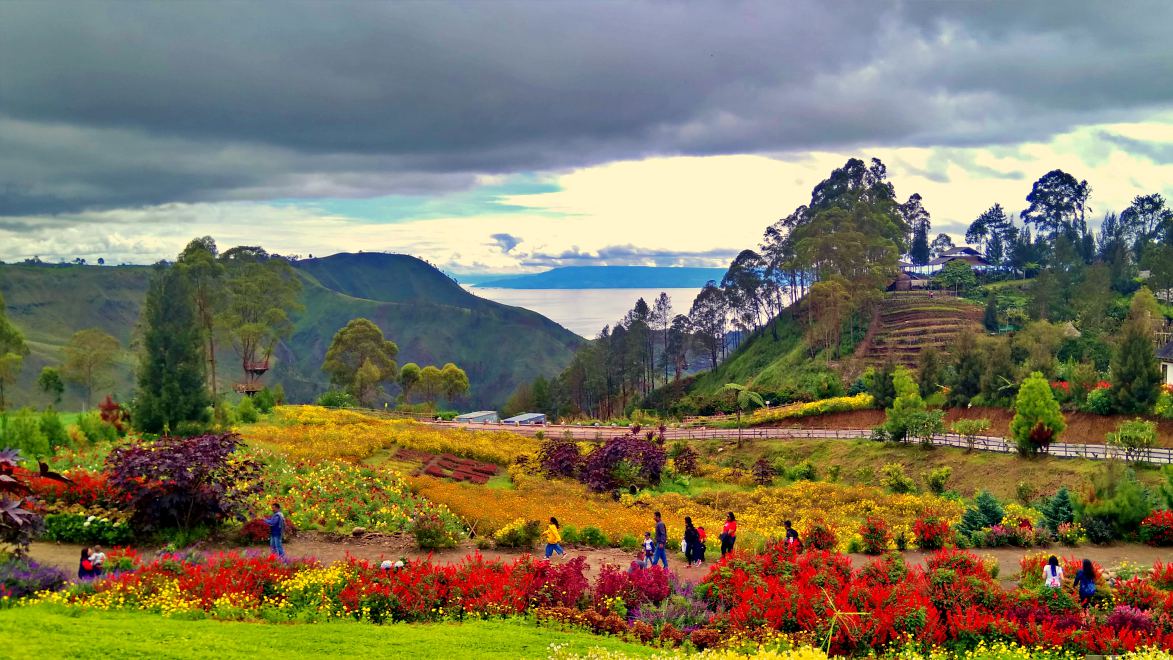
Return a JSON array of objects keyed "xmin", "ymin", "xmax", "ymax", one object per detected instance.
[{"xmin": 219, "ymin": 246, "xmax": 301, "ymax": 385}]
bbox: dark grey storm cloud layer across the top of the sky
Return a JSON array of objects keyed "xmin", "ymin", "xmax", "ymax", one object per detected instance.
[{"xmin": 0, "ymin": 1, "xmax": 1173, "ymax": 216}]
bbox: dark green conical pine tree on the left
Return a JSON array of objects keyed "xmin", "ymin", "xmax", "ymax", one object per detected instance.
[{"xmin": 134, "ymin": 266, "xmax": 211, "ymax": 433}]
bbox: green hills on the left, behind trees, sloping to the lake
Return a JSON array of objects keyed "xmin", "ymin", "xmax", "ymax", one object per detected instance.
[{"xmin": 0, "ymin": 253, "xmax": 582, "ymax": 409}]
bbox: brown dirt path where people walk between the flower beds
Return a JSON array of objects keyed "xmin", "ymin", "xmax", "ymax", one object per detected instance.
[{"xmin": 30, "ymin": 533, "xmax": 1173, "ymax": 586}]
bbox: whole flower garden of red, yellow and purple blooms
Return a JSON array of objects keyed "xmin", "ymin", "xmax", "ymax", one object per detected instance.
[{"xmin": 0, "ymin": 407, "xmax": 1173, "ymax": 658}]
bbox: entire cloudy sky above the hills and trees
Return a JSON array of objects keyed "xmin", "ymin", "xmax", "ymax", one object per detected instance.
[{"xmin": 0, "ymin": 0, "xmax": 1173, "ymax": 273}]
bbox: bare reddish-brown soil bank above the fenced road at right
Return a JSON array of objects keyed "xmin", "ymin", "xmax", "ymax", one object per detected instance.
[{"xmin": 778, "ymin": 408, "xmax": 1173, "ymax": 448}]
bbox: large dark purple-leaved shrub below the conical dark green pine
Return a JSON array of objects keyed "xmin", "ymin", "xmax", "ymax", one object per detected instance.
[{"xmin": 106, "ymin": 434, "xmax": 260, "ymax": 530}]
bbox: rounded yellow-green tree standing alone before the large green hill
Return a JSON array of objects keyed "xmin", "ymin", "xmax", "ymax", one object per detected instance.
[{"xmin": 321, "ymin": 319, "xmax": 399, "ymax": 407}]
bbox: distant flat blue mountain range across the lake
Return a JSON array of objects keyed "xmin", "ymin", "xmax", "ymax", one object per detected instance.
[{"xmin": 461, "ymin": 266, "xmax": 725, "ymax": 288}]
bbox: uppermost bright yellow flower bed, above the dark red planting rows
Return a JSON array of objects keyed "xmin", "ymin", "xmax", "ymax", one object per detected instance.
[{"xmin": 249, "ymin": 406, "xmax": 538, "ymax": 464}]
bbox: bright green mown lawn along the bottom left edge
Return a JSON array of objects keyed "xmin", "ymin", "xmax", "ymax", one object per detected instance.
[{"xmin": 0, "ymin": 605, "xmax": 652, "ymax": 660}]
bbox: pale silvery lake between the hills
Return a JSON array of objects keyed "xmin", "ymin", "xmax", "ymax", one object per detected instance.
[{"xmin": 466, "ymin": 286, "xmax": 700, "ymax": 339}]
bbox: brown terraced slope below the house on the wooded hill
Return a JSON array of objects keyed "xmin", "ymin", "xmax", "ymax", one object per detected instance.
[{"xmin": 855, "ymin": 291, "xmax": 982, "ymax": 367}]
